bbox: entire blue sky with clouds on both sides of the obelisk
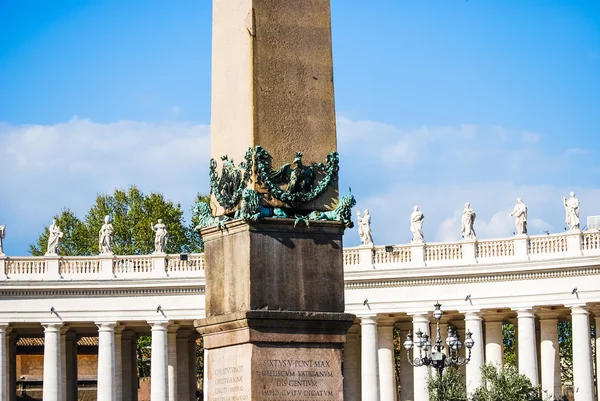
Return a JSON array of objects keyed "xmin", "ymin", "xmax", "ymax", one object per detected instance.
[{"xmin": 0, "ymin": 0, "xmax": 600, "ymax": 255}]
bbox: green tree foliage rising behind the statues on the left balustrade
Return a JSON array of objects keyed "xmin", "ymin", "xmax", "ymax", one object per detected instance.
[{"xmin": 30, "ymin": 186, "xmax": 207, "ymax": 256}]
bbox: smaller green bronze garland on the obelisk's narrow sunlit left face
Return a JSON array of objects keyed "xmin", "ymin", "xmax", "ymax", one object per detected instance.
[{"xmin": 209, "ymin": 148, "xmax": 253, "ymax": 210}]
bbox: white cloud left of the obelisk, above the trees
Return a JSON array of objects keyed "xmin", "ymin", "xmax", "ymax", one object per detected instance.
[{"xmin": 0, "ymin": 117, "xmax": 210, "ymax": 253}]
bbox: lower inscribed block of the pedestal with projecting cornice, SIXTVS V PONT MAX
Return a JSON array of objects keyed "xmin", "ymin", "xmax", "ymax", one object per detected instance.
[{"xmin": 195, "ymin": 310, "xmax": 355, "ymax": 401}]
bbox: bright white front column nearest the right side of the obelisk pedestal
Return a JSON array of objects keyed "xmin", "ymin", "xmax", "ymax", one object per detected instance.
[{"xmin": 360, "ymin": 316, "xmax": 379, "ymax": 401}]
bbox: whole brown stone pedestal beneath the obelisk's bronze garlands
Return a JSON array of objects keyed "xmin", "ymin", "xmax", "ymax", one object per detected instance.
[{"xmin": 195, "ymin": 219, "xmax": 355, "ymax": 401}]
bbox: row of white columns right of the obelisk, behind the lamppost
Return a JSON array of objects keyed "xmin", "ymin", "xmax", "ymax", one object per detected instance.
[{"xmin": 343, "ymin": 304, "xmax": 600, "ymax": 401}]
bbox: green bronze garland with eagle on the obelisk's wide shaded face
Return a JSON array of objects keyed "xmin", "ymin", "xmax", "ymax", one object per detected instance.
[{"xmin": 254, "ymin": 146, "xmax": 339, "ymax": 205}]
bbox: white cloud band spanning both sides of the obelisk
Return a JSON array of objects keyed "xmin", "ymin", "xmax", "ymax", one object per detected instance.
[{"xmin": 0, "ymin": 116, "xmax": 600, "ymax": 254}]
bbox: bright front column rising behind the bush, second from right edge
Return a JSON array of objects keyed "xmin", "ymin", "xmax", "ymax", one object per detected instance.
[{"xmin": 517, "ymin": 309, "xmax": 539, "ymax": 386}]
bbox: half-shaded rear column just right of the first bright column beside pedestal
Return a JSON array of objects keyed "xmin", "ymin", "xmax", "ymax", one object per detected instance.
[{"xmin": 377, "ymin": 319, "xmax": 398, "ymax": 401}]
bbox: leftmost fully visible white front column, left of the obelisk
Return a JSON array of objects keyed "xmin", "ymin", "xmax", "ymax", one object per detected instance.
[{"xmin": 42, "ymin": 322, "xmax": 62, "ymax": 401}]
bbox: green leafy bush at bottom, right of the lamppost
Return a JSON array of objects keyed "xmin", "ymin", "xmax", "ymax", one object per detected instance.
[{"xmin": 471, "ymin": 364, "xmax": 542, "ymax": 401}]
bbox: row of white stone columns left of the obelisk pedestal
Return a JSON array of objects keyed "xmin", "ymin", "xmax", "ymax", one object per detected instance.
[{"xmin": 0, "ymin": 321, "xmax": 198, "ymax": 401}]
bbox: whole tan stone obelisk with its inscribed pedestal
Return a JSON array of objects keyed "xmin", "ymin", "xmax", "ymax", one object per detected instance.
[{"xmin": 196, "ymin": 0, "xmax": 354, "ymax": 401}]
